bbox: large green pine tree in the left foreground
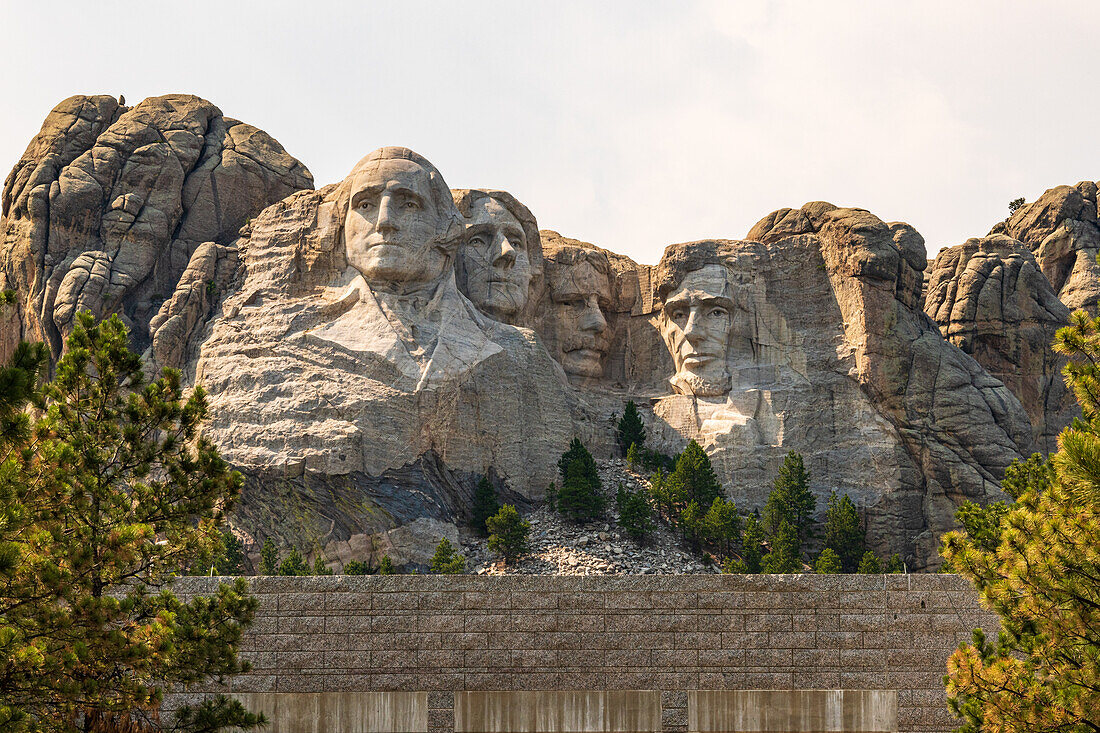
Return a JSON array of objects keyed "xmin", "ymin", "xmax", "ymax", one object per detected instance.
[{"xmin": 0, "ymin": 313, "xmax": 262, "ymax": 731}]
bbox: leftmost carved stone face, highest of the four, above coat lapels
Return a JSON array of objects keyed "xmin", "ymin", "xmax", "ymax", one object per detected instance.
[{"xmin": 344, "ymin": 158, "xmax": 450, "ymax": 285}]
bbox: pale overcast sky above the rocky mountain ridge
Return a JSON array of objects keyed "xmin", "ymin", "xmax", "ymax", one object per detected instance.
[{"xmin": 0, "ymin": 0, "xmax": 1100, "ymax": 263}]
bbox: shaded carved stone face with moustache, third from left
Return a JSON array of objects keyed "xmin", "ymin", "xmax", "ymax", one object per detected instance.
[{"xmin": 550, "ymin": 260, "xmax": 612, "ymax": 378}]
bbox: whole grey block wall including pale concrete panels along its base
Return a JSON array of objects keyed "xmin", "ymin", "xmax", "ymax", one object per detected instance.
[{"xmin": 168, "ymin": 575, "xmax": 997, "ymax": 733}]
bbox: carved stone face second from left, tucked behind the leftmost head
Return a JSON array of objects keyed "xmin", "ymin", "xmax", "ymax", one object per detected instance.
[{"xmin": 461, "ymin": 196, "xmax": 531, "ymax": 321}]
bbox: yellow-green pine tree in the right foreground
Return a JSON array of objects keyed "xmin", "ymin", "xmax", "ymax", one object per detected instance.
[{"xmin": 943, "ymin": 310, "xmax": 1100, "ymax": 733}]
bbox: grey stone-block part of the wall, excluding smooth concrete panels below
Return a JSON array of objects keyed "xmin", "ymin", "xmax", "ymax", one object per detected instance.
[{"xmin": 169, "ymin": 575, "xmax": 998, "ymax": 733}]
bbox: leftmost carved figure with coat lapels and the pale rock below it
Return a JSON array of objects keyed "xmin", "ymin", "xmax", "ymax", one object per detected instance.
[{"xmin": 197, "ymin": 149, "xmax": 578, "ymax": 564}]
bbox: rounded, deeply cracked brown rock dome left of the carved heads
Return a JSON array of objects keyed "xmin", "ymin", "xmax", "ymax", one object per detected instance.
[{"xmin": 0, "ymin": 95, "xmax": 312, "ymax": 367}]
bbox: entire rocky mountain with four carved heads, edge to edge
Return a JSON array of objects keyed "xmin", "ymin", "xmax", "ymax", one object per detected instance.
[{"xmin": 0, "ymin": 96, "xmax": 1100, "ymax": 568}]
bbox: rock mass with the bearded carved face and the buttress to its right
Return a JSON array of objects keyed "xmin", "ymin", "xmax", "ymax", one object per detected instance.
[{"xmin": 633, "ymin": 204, "xmax": 1031, "ymax": 567}]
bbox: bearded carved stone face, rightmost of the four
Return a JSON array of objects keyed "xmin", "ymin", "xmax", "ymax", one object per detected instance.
[{"xmin": 661, "ymin": 265, "xmax": 733, "ymax": 396}]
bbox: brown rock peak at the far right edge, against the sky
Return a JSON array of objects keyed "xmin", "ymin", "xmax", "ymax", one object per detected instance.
[{"xmin": 1003, "ymin": 180, "xmax": 1100, "ymax": 310}]
